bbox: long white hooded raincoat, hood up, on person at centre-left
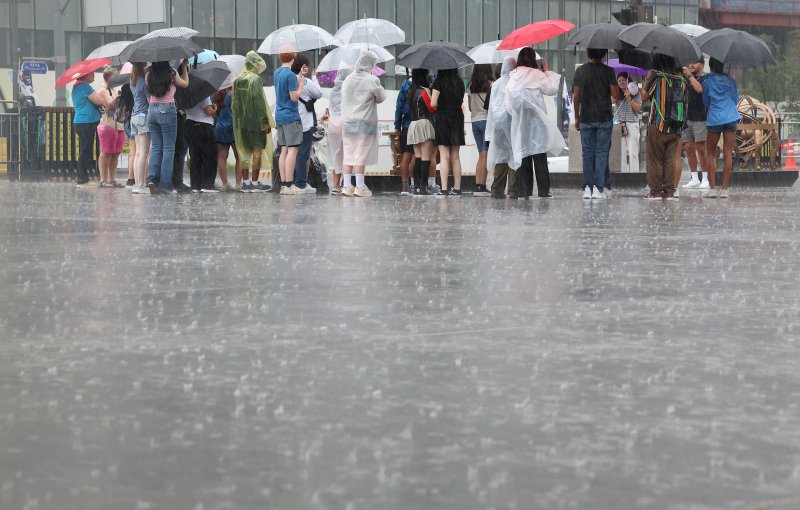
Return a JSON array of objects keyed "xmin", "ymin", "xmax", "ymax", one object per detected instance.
[{"xmin": 342, "ymin": 50, "xmax": 386, "ymax": 166}]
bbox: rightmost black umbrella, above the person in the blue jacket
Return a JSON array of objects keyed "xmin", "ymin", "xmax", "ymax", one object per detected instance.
[{"xmin": 695, "ymin": 28, "xmax": 775, "ymax": 69}]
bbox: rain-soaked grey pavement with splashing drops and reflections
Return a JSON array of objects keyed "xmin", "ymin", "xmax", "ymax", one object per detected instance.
[{"xmin": 0, "ymin": 181, "xmax": 800, "ymax": 510}]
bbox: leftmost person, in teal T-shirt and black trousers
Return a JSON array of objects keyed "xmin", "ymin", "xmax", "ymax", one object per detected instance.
[{"xmin": 72, "ymin": 73, "xmax": 105, "ymax": 189}]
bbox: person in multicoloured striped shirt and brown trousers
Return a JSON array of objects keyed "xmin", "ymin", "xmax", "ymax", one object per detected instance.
[{"xmin": 642, "ymin": 54, "xmax": 687, "ymax": 201}]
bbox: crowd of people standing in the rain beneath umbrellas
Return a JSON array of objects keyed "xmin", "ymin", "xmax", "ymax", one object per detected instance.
[{"xmin": 72, "ymin": 47, "xmax": 741, "ymax": 200}]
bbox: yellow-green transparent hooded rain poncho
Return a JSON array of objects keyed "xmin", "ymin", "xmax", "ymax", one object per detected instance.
[{"xmin": 231, "ymin": 51, "xmax": 275, "ymax": 169}]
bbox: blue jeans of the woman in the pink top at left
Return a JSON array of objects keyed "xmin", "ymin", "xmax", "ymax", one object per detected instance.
[{"xmin": 147, "ymin": 103, "xmax": 178, "ymax": 191}]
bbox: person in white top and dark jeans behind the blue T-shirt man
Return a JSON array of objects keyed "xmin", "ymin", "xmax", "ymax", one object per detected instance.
[{"xmin": 292, "ymin": 55, "xmax": 322, "ymax": 194}]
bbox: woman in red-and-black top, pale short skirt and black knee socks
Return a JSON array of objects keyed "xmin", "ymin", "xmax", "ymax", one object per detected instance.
[{"xmin": 406, "ymin": 69, "xmax": 436, "ymax": 197}]
